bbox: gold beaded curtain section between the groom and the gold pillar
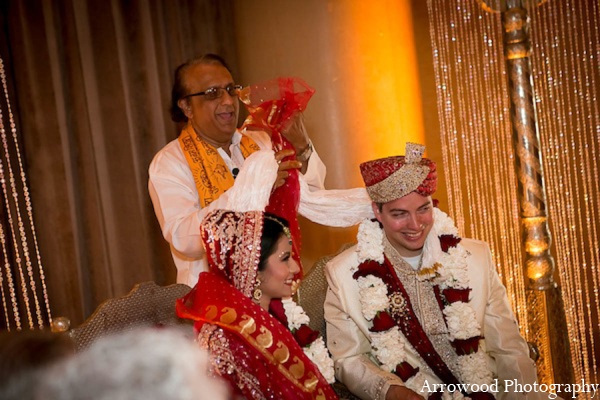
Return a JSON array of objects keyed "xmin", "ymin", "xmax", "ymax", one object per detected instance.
[{"xmin": 428, "ymin": 0, "xmax": 529, "ymax": 328}]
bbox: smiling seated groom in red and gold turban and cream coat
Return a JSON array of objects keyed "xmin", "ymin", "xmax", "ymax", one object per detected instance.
[{"xmin": 325, "ymin": 143, "xmax": 547, "ymax": 400}]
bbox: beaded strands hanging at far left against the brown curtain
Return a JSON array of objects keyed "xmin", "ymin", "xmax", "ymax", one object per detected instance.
[{"xmin": 0, "ymin": 58, "xmax": 52, "ymax": 331}]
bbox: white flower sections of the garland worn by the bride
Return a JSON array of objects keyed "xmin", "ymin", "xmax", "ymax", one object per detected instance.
[{"xmin": 281, "ymin": 298, "xmax": 335, "ymax": 384}]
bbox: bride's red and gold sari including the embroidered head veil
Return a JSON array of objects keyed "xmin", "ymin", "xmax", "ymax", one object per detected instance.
[{"xmin": 177, "ymin": 210, "xmax": 337, "ymax": 400}]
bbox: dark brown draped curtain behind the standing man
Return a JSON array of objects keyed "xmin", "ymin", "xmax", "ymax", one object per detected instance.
[{"xmin": 1, "ymin": 0, "xmax": 236, "ymax": 325}]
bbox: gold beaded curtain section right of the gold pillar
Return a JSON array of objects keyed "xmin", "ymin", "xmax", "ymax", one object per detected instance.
[{"xmin": 531, "ymin": 0, "xmax": 600, "ymax": 383}]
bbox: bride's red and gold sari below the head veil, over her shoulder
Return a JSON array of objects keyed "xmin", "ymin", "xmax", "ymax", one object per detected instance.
[{"xmin": 177, "ymin": 272, "xmax": 337, "ymax": 399}]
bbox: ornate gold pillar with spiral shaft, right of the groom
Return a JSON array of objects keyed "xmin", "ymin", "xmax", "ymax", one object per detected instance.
[{"xmin": 500, "ymin": 0, "xmax": 573, "ymax": 384}]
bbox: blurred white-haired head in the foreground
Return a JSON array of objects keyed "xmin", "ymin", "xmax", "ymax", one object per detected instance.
[{"xmin": 38, "ymin": 328, "xmax": 228, "ymax": 400}]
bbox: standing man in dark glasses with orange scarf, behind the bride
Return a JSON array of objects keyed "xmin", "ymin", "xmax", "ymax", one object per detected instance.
[{"xmin": 148, "ymin": 54, "xmax": 325, "ymax": 286}]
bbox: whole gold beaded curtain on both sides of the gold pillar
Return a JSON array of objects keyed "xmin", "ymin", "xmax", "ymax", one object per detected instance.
[{"xmin": 428, "ymin": 0, "xmax": 600, "ymax": 390}]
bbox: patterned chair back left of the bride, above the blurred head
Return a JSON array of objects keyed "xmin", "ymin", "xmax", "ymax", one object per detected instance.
[{"xmin": 69, "ymin": 282, "xmax": 192, "ymax": 350}]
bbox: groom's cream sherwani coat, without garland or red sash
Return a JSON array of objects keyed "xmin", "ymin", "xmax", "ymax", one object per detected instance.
[{"xmin": 325, "ymin": 239, "xmax": 547, "ymax": 399}]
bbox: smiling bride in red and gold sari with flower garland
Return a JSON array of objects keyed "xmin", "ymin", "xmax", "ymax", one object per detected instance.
[{"xmin": 177, "ymin": 210, "xmax": 337, "ymax": 399}]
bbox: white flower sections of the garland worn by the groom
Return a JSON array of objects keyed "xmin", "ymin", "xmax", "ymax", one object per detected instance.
[{"xmin": 357, "ymin": 208, "xmax": 493, "ymax": 399}]
